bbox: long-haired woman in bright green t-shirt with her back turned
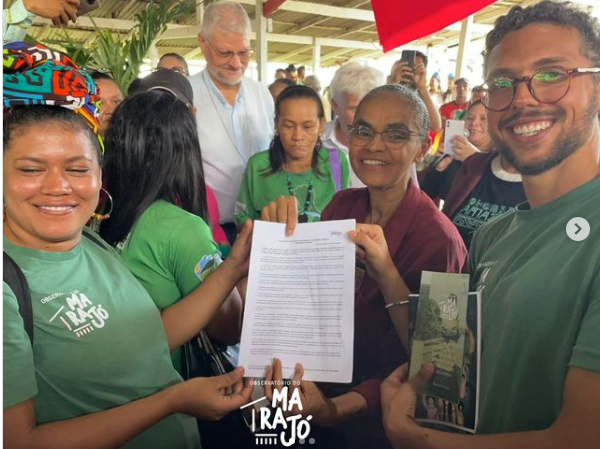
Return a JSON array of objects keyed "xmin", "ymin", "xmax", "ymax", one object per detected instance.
[{"xmin": 100, "ymin": 86, "xmax": 242, "ymax": 377}]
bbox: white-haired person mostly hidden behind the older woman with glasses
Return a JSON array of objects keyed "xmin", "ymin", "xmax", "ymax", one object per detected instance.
[{"xmin": 322, "ymin": 62, "xmax": 383, "ymax": 187}]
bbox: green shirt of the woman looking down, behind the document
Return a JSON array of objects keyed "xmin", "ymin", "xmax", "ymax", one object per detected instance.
[{"xmin": 235, "ymin": 148, "xmax": 350, "ymax": 226}]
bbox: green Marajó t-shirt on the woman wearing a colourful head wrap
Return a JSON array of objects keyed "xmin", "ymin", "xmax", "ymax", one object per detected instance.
[{"xmin": 3, "ymin": 233, "xmax": 200, "ymax": 449}]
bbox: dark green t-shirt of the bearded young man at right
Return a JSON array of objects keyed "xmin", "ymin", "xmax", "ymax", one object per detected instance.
[{"xmin": 470, "ymin": 178, "xmax": 600, "ymax": 433}]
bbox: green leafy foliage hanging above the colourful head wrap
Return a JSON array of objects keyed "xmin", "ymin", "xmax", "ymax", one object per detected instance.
[{"xmin": 44, "ymin": 0, "xmax": 196, "ymax": 92}]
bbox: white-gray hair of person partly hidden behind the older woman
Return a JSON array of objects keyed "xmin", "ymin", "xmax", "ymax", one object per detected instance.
[{"xmin": 330, "ymin": 61, "xmax": 383, "ymax": 102}]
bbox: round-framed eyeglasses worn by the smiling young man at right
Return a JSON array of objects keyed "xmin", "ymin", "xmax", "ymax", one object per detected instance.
[{"xmin": 481, "ymin": 67, "xmax": 600, "ymax": 112}]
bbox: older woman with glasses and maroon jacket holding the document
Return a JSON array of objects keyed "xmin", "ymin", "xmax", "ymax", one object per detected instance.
[{"xmin": 263, "ymin": 85, "xmax": 467, "ymax": 448}]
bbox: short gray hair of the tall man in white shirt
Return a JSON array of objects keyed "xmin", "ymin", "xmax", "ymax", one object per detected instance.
[{"xmin": 200, "ymin": 1, "xmax": 252, "ymax": 39}]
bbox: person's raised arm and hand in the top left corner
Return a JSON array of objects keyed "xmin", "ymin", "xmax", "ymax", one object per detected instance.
[{"xmin": 2, "ymin": 0, "xmax": 79, "ymax": 43}]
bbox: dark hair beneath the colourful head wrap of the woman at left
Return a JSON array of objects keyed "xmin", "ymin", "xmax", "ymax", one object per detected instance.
[{"xmin": 2, "ymin": 106, "xmax": 102, "ymax": 163}]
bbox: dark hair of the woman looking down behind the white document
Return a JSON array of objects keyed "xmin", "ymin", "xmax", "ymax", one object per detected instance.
[{"xmin": 263, "ymin": 85, "xmax": 325, "ymax": 176}]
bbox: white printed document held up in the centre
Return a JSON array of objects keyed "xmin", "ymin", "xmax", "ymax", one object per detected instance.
[{"xmin": 239, "ymin": 220, "xmax": 356, "ymax": 383}]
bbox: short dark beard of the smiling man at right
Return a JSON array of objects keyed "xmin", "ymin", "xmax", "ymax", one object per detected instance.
[{"xmin": 490, "ymin": 90, "xmax": 599, "ymax": 176}]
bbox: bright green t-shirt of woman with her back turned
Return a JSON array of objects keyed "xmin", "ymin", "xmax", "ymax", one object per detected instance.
[{"xmin": 121, "ymin": 200, "xmax": 221, "ymax": 372}]
